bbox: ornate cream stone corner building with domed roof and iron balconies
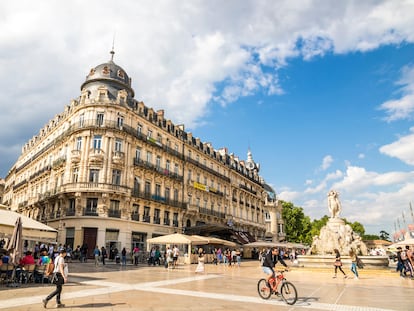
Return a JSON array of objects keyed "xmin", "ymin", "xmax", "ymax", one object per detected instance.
[{"xmin": 3, "ymin": 51, "xmax": 284, "ymax": 256}]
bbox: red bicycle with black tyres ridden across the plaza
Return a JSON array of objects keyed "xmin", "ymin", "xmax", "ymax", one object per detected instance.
[{"xmin": 257, "ymin": 270, "xmax": 298, "ymax": 305}]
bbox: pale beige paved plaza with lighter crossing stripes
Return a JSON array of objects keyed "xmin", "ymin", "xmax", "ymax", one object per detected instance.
[{"xmin": 0, "ymin": 261, "xmax": 414, "ymax": 311}]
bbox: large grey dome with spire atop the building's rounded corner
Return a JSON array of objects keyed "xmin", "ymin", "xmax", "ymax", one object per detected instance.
[{"xmin": 81, "ymin": 51, "xmax": 135, "ymax": 99}]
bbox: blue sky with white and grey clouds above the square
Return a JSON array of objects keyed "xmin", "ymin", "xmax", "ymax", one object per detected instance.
[{"xmin": 0, "ymin": 0, "xmax": 414, "ymax": 238}]
